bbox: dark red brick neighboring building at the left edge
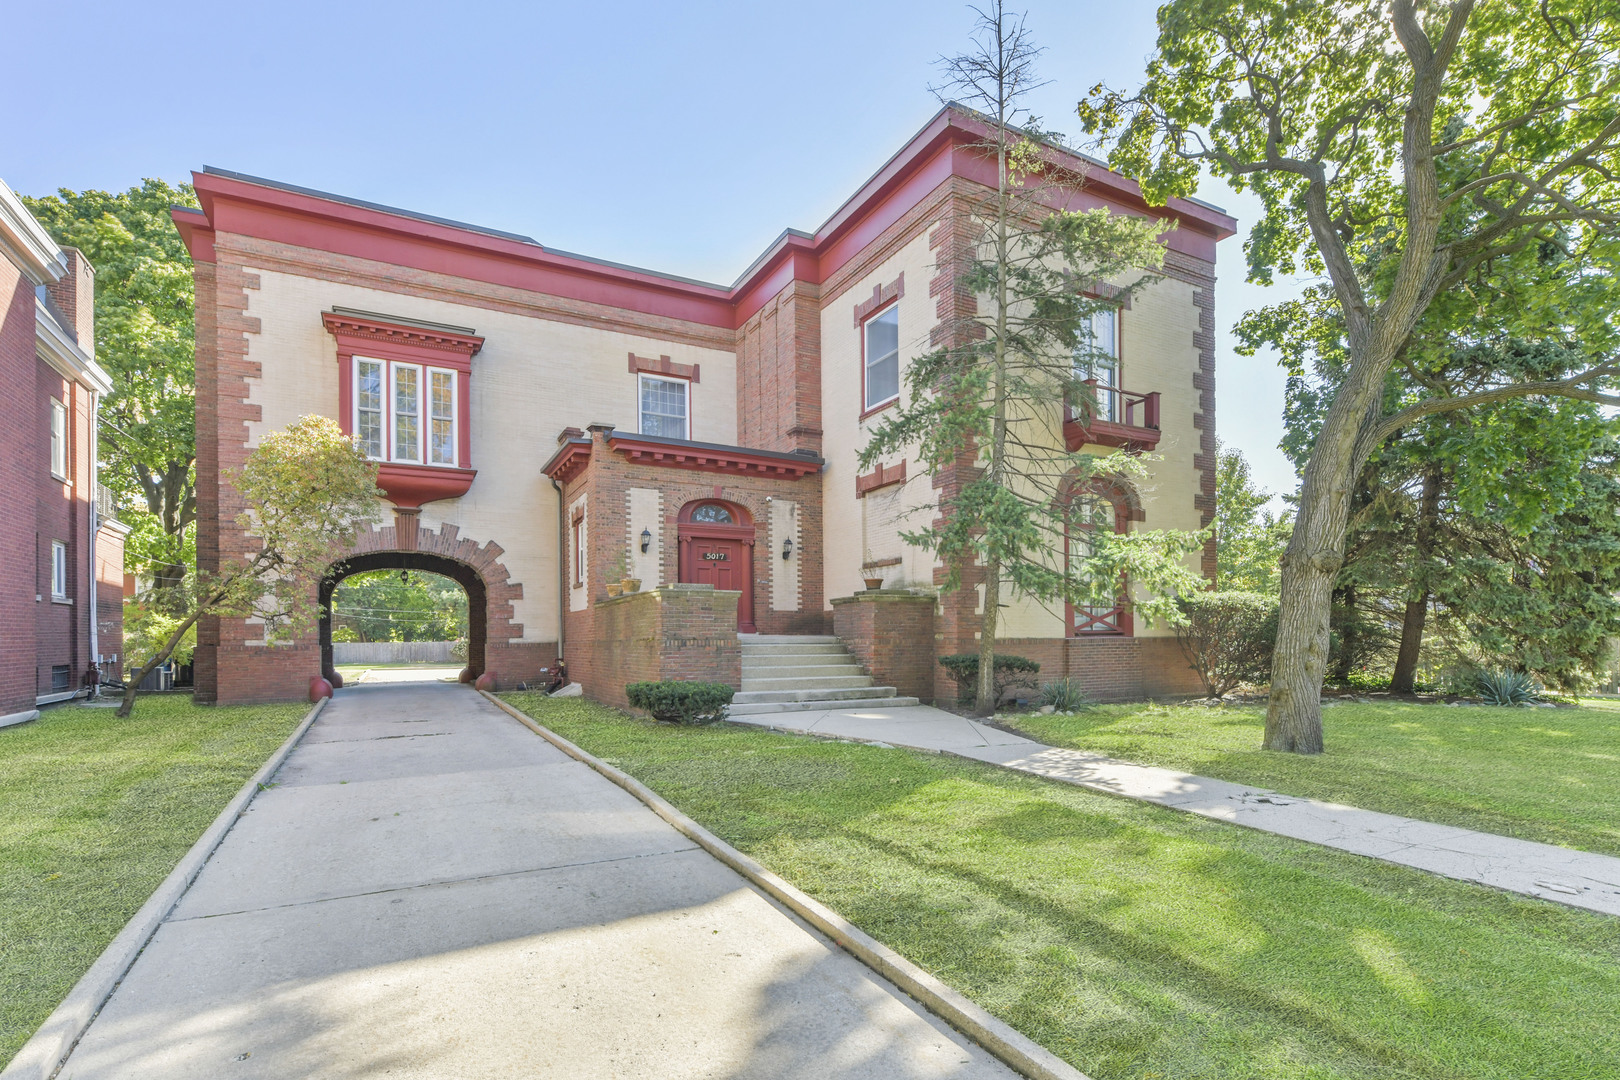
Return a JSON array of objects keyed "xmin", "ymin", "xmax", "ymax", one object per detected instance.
[{"xmin": 0, "ymin": 181, "xmax": 128, "ymax": 725}]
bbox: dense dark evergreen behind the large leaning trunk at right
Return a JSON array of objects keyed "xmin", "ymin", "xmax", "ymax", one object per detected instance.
[{"xmin": 1285, "ymin": 335, "xmax": 1620, "ymax": 691}]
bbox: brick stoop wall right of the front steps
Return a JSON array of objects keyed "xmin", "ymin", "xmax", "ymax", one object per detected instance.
[{"xmin": 833, "ymin": 589, "xmax": 936, "ymax": 704}]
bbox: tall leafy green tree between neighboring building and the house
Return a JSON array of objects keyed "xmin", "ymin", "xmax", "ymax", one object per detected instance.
[{"xmin": 24, "ymin": 180, "xmax": 196, "ymax": 607}]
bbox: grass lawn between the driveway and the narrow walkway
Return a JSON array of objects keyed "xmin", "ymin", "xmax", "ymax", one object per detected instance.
[{"xmin": 507, "ymin": 693, "xmax": 1620, "ymax": 1080}]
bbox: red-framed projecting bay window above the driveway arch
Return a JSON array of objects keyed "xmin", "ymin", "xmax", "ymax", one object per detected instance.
[{"xmin": 321, "ymin": 308, "xmax": 484, "ymax": 507}]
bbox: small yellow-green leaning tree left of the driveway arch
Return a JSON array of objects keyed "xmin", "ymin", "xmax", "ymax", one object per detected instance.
[{"xmin": 118, "ymin": 416, "xmax": 382, "ymax": 716}]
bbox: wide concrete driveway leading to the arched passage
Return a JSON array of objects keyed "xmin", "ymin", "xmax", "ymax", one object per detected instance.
[{"xmin": 60, "ymin": 683, "xmax": 1013, "ymax": 1080}]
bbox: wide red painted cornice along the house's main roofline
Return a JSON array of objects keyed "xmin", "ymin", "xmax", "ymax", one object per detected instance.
[{"xmin": 173, "ymin": 105, "xmax": 1236, "ymax": 329}]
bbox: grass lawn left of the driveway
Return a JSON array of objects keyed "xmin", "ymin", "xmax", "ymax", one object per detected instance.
[{"xmin": 0, "ymin": 695, "xmax": 309, "ymax": 1067}]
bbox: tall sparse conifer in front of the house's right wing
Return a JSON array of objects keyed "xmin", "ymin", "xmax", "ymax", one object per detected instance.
[{"xmin": 860, "ymin": 0, "xmax": 1205, "ymax": 712}]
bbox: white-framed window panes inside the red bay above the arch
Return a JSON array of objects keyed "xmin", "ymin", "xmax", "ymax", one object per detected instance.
[{"xmin": 353, "ymin": 356, "xmax": 457, "ymax": 465}]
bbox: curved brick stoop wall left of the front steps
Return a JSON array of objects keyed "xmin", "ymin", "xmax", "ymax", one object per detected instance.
[{"xmin": 569, "ymin": 585, "xmax": 742, "ymax": 706}]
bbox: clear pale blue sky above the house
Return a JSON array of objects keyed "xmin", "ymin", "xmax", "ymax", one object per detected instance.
[{"xmin": 0, "ymin": 0, "xmax": 1293, "ymax": 505}]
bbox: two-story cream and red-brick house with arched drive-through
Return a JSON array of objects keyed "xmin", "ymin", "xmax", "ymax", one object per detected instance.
[{"xmin": 173, "ymin": 108, "xmax": 1234, "ymax": 701}]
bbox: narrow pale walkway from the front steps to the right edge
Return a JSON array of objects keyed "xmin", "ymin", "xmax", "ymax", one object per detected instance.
[{"xmin": 734, "ymin": 706, "xmax": 1620, "ymax": 915}]
